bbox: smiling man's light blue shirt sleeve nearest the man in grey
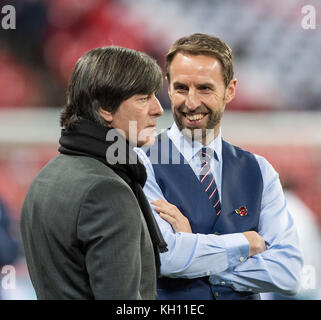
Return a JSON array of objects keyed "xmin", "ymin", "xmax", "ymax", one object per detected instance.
[{"xmin": 136, "ymin": 149, "xmax": 250, "ymax": 278}]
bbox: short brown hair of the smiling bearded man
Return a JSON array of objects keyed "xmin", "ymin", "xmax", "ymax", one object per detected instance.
[{"xmin": 166, "ymin": 33, "xmax": 234, "ymax": 87}]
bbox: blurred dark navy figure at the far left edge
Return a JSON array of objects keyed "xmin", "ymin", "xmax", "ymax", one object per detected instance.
[{"xmin": 0, "ymin": 201, "xmax": 18, "ymax": 267}]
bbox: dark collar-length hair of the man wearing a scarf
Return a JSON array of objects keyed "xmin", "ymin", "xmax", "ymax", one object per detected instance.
[{"xmin": 60, "ymin": 46, "xmax": 163, "ymax": 130}]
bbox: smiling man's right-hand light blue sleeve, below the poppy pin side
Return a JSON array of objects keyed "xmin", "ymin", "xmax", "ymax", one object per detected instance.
[{"xmin": 211, "ymin": 157, "xmax": 303, "ymax": 294}]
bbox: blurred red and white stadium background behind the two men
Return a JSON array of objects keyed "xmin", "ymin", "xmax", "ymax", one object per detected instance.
[{"xmin": 0, "ymin": 0, "xmax": 321, "ymax": 299}]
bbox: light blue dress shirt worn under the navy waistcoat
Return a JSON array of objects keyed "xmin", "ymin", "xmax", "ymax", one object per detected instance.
[{"xmin": 136, "ymin": 123, "xmax": 303, "ymax": 294}]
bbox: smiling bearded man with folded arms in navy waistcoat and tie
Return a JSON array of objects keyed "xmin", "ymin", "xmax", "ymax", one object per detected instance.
[{"xmin": 137, "ymin": 34, "xmax": 303, "ymax": 299}]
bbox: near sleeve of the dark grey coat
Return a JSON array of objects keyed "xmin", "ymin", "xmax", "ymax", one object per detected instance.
[{"xmin": 77, "ymin": 179, "xmax": 142, "ymax": 300}]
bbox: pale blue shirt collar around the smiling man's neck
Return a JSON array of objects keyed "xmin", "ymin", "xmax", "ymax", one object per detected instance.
[{"xmin": 167, "ymin": 122, "xmax": 222, "ymax": 162}]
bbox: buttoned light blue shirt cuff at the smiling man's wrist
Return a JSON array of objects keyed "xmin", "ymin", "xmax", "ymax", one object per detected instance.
[{"xmin": 220, "ymin": 233, "xmax": 250, "ymax": 268}]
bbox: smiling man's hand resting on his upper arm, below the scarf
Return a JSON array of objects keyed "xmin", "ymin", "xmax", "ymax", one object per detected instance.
[{"xmin": 151, "ymin": 199, "xmax": 192, "ymax": 233}]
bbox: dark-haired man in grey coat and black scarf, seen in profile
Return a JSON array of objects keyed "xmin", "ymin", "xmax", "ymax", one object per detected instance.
[{"xmin": 21, "ymin": 47, "xmax": 166, "ymax": 299}]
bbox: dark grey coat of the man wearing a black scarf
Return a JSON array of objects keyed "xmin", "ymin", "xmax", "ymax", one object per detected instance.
[{"xmin": 21, "ymin": 155, "xmax": 156, "ymax": 299}]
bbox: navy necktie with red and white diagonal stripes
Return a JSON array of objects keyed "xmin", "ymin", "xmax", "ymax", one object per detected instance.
[{"xmin": 200, "ymin": 147, "xmax": 221, "ymax": 215}]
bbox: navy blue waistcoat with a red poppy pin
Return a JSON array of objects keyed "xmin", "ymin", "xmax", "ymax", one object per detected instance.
[{"xmin": 146, "ymin": 132, "xmax": 263, "ymax": 300}]
